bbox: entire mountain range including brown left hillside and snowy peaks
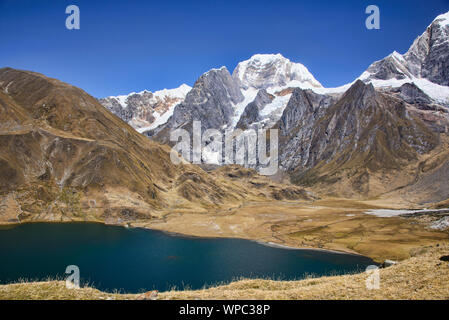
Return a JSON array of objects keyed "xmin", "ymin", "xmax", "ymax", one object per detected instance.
[{"xmin": 0, "ymin": 13, "xmax": 449, "ymax": 228}]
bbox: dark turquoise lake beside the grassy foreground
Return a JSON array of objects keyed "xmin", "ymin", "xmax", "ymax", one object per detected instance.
[{"xmin": 0, "ymin": 223, "xmax": 374, "ymax": 293}]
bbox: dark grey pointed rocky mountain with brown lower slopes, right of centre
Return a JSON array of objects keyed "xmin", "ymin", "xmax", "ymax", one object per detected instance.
[{"xmin": 279, "ymin": 80, "xmax": 439, "ymax": 196}]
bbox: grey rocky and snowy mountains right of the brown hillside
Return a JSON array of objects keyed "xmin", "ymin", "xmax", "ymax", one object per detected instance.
[{"xmin": 95, "ymin": 12, "xmax": 449, "ymax": 201}]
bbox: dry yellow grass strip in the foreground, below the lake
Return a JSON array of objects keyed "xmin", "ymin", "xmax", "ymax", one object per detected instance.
[{"xmin": 0, "ymin": 243, "xmax": 449, "ymax": 303}]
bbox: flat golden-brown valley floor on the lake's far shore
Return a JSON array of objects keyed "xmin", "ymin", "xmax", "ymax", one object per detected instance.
[{"xmin": 132, "ymin": 199, "xmax": 449, "ymax": 262}]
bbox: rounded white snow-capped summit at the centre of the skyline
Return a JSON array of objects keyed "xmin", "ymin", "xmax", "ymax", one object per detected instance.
[{"xmin": 232, "ymin": 53, "xmax": 322, "ymax": 90}]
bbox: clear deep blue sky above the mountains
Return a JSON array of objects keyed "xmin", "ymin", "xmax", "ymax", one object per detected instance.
[{"xmin": 0, "ymin": 0, "xmax": 449, "ymax": 97}]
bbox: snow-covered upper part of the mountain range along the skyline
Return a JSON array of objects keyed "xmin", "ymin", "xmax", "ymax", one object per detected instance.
[{"xmin": 100, "ymin": 13, "xmax": 449, "ymax": 134}]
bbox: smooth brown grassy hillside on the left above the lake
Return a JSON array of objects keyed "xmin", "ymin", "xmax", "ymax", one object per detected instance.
[{"xmin": 0, "ymin": 68, "xmax": 305, "ymax": 223}]
